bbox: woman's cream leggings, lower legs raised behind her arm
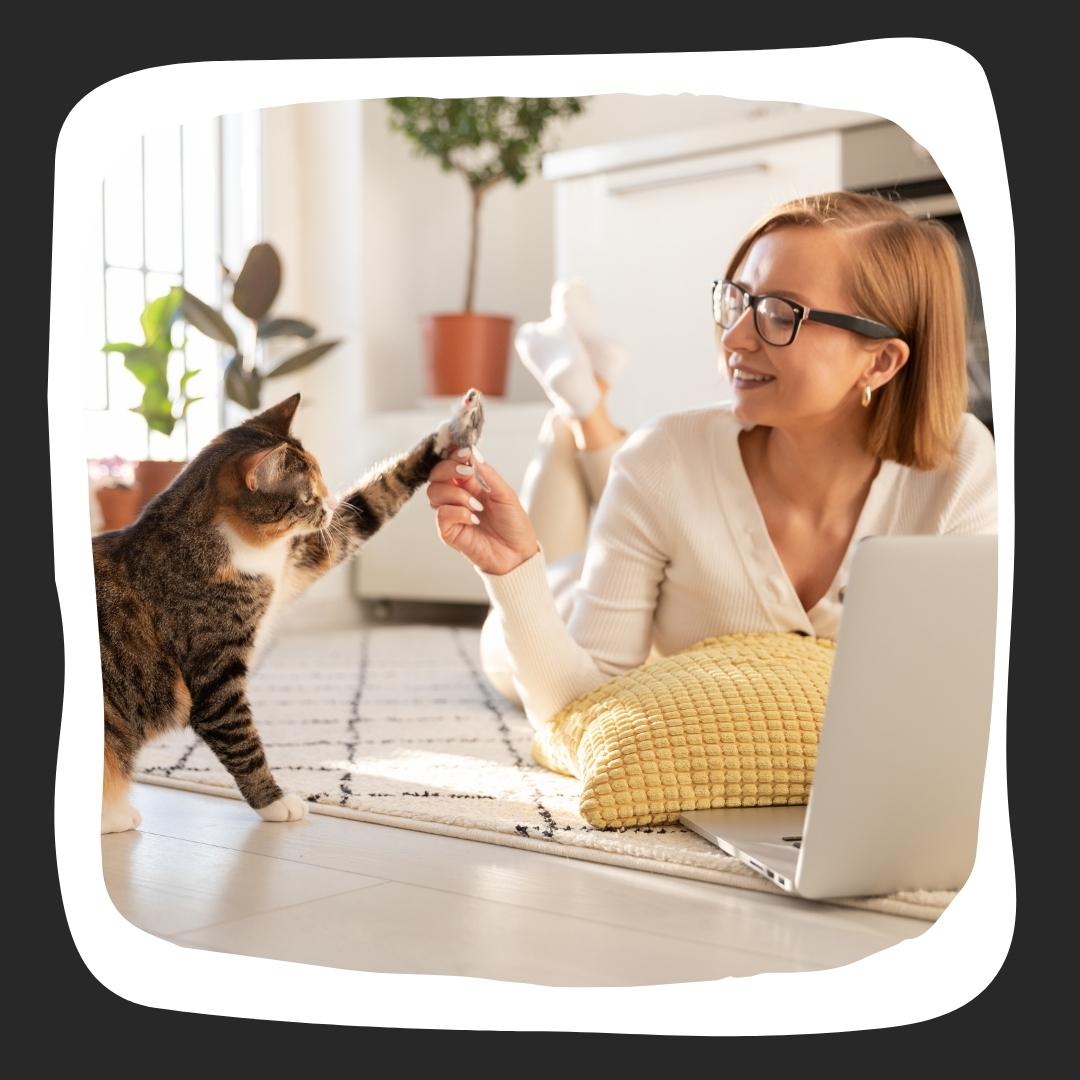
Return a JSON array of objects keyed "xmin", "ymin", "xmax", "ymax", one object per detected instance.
[{"xmin": 480, "ymin": 409, "xmax": 627, "ymax": 704}]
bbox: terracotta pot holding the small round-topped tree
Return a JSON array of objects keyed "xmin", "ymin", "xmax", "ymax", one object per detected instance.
[{"xmin": 421, "ymin": 314, "xmax": 514, "ymax": 397}]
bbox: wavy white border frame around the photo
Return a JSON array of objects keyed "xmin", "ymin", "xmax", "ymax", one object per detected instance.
[{"xmin": 49, "ymin": 39, "xmax": 1015, "ymax": 1035}]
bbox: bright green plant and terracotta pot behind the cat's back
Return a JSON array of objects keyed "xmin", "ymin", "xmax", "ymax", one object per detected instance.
[{"xmin": 103, "ymin": 286, "xmax": 201, "ymax": 524}]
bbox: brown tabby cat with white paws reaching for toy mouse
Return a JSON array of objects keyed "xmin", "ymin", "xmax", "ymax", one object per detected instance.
[{"xmin": 93, "ymin": 390, "xmax": 484, "ymax": 833}]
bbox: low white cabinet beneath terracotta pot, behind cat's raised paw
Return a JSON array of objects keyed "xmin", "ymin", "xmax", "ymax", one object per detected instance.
[{"xmin": 353, "ymin": 397, "xmax": 550, "ymax": 604}]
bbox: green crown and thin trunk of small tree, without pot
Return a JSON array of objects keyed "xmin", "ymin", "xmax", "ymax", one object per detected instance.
[{"xmin": 387, "ymin": 97, "xmax": 584, "ymax": 312}]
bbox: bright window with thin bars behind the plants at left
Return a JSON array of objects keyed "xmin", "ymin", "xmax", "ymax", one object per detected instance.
[{"xmin": 83, "ymin": 113, "xmax": 260, "ymax": 460}]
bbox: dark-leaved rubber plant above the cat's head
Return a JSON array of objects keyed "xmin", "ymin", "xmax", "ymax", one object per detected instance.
[{"xmin": 183, "ymin": 243, "xmax": 341, "ymax": 413}]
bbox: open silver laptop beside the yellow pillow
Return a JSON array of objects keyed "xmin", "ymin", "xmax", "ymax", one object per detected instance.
[{"xmin": 680, "ymin": 536, "xmax": 997, "ymax": 900}]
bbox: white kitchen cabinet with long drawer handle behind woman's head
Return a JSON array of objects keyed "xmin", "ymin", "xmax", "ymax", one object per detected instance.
[{"xmin": 557, "ymin": 130, "xmax": 841, "ymax": 428}]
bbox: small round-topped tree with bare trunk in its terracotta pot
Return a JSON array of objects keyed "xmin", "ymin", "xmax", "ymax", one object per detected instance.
[{"xmin": 387, "ymin": 97, "xmax": 583, "ymax": 396}]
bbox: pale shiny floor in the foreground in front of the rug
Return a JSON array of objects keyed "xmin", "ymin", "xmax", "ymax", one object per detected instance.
[{"xmin": 102, "ymin": 784, "xmax": 930, "ymax": 986}]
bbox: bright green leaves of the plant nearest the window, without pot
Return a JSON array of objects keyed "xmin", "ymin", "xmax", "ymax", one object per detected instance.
[{"xmin": 103, "ymin": 286, "xmax": 202, "ymax": 435}]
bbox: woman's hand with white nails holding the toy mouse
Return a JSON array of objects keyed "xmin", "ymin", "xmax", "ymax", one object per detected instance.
[{"xmin": 428, "ymin": 449, "xmax": 540, "ymax": 573}]
